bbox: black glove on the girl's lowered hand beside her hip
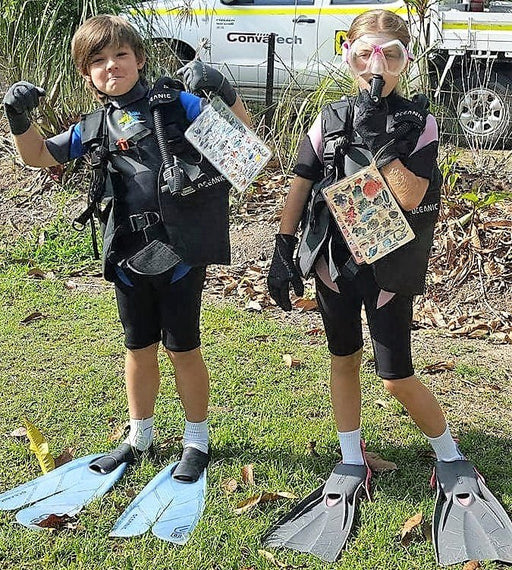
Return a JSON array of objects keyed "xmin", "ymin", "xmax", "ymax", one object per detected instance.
[{"xmin": 267, "ymin": 234, "xmax": 304, "ymax": 311}]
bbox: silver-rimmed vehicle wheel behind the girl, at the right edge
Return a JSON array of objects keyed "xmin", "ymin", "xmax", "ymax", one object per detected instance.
[{"xmin": 451, "ymin": 73, "xmax": 512, "ymax": 149}]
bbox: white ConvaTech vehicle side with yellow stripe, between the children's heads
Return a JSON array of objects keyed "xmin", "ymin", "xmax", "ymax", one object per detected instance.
[{"xmin": 134, "ymin": 0, "xmax": 407, "ymax": 98}]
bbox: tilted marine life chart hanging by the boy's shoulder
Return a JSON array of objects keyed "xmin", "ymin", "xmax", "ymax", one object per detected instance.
[{"xmin": 185, "ymin": 97, "xmax": 272, "ymax": 190}]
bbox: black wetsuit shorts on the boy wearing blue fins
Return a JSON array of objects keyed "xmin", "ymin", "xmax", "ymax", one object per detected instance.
[{"xmin": 115, "ymin": 267, "xmax": 206, "ymax": 352}]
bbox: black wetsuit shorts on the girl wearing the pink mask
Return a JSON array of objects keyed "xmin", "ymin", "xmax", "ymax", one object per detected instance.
[{"xmin": 316, "ymin": 265, "xmax": 414, "ymax": 380}]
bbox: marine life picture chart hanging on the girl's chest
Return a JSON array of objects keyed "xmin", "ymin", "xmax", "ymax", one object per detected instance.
[{"xmin": 323, "ymin": 164, "xmax": 414, "ymax": 263}]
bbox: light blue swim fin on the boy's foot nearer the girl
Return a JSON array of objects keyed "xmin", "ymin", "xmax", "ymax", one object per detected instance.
[{"xmin": 109, "ymin": 462, "xmax": 206, "ymax": 544}]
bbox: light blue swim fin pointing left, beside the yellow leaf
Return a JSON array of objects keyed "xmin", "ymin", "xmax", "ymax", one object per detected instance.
[{"xmin": 0, "ymin": 454, "xmax": 127, "ymax": 530}]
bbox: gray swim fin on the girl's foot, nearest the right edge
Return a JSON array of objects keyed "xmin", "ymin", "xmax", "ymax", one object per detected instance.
[{"xmin": 432, "ymin": 460, "xmax": 512, "ymax": 565}]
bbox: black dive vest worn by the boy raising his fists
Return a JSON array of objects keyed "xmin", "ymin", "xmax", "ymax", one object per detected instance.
[{"xmin": 81, "ymin": 89, "xmax": 230, "ymax": 280}]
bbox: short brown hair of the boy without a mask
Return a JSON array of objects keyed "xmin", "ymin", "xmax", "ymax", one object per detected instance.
[{"xmin": 71, "ymin": 14, "xmax": 146, "ymax": 76}]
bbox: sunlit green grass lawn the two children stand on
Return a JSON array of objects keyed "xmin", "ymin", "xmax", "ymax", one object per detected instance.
[{"xmin": 0, "ymin": 242, "xmax": 512, "ymax": 570}]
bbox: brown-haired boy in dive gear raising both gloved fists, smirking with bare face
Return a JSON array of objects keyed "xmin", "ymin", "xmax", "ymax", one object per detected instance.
[{"xmin": 4, "ymin": 15, "xmax": 249, "ymax": 482}]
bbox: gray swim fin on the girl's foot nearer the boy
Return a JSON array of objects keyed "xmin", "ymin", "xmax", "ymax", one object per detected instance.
[{"xmin": 264, "ymin": 463, "xmax": 371, "ymax": 562}]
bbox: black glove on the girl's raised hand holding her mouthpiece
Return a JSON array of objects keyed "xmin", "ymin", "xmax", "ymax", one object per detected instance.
[{"xmin": 354, "ymin": 89, "xmax": 400, "ymax": 168}]
